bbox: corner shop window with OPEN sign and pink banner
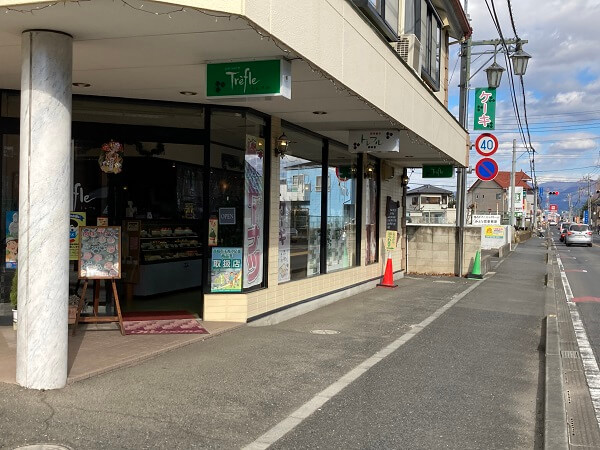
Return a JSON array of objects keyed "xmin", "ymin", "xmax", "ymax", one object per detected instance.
[{"xmin": 208, "ymin": 110, "xmax": 266, "ymax": 292}]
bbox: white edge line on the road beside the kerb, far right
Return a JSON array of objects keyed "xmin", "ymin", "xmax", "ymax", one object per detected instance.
[{"xmin": 556, "ymin": 244, "xmax": 600, "ymax": 426}]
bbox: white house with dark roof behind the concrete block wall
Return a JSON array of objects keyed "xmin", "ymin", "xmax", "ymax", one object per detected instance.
[{"xmin": 406, "ymin": 184, "xmax": 456, "ymax": 223}]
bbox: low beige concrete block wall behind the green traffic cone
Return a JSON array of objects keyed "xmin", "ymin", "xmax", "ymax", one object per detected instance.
[{"xmin": 406, "ymin": 224, "xmax": 481, "ymax": 275}]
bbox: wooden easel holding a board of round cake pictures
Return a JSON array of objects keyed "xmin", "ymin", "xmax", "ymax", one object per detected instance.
[{"xmin": 73, "ymin": 226, "xmax": 125, "ymax": 335}]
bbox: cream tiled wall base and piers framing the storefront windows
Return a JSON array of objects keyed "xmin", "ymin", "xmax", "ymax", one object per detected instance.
[{"xmin": 204, "ymin": 118, "xmax": 406, "ymax": 322}]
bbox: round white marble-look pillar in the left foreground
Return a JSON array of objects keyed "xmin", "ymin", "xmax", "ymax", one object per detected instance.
[{"xmin": 17, "ymin": 30, "xmax": 73, "ymax": 389}]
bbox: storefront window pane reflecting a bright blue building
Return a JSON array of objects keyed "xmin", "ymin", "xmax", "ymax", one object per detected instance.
[{"xmin": 328, "ymin": 144, "xmax": 358, "ymax": 272}]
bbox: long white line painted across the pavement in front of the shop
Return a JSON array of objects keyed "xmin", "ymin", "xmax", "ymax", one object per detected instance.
[{"xmin": 243, "ymin": 277, "xmax": 483, "ymax": 450}]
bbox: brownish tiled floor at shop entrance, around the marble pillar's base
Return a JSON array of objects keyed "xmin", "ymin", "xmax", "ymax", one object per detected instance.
[{"xmin": 0, "ymin": 322, "xmax": 245, "ymax": 383}]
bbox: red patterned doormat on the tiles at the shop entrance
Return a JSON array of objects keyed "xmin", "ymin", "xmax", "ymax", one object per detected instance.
[{"xmin": 123, "ymin": 311, "xmax": 209, "ymax": 334}]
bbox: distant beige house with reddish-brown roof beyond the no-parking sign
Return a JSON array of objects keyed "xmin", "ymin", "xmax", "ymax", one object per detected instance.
[{"xmin": 467, "ymin": 170, "xmax": 534, "ymax": 224}]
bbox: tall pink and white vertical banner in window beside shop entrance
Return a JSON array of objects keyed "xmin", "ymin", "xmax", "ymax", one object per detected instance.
[{"xmin": 243, "ymin": 134, "xmax": 265, "ymax": 288}]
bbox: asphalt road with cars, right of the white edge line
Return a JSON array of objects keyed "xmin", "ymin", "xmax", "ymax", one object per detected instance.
[{"xmin": 550, "ymin": 227, "xmax": 600, "ymax": 364}]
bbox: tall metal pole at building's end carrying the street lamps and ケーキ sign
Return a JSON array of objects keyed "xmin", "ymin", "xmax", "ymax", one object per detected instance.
[{"xmin": 455, "ymin": 38, "xmax": 471, "ymax": 277}]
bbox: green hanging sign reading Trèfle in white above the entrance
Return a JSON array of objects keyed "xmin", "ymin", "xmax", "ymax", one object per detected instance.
[{"xmin": 206, "ymin": 59, "xmax": 292, "ymax": 98}]
